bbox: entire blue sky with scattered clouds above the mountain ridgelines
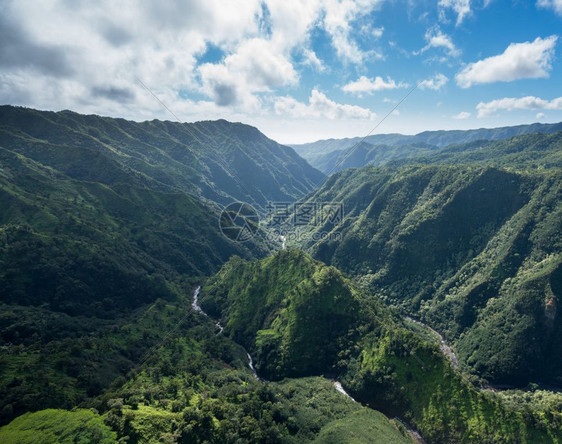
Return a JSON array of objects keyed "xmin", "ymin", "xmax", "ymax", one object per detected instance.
[{"xmin": 0, "ymin": 0, "xmax": 562, "ymax": 143}]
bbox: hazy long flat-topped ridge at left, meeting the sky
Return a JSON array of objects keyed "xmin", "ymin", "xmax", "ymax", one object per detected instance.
[{"xmin": 0, "ymin": 106, "xmax": 323, "ymax": 210}]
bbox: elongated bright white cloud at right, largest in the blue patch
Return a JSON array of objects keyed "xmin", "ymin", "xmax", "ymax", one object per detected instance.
[{"xmin": 456, "ymin": 35, "xmax": 558, "ymax": 88}]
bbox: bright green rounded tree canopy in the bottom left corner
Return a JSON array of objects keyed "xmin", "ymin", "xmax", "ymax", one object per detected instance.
[{"xmin": 0, "ymin": 409, "xmax": 117, "ymax": 444}]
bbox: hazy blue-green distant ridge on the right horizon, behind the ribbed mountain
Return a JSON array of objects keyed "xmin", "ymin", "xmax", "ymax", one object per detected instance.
[{"xmin": 293, "ymin": 122, "xmax": 562, "ymax": 173}]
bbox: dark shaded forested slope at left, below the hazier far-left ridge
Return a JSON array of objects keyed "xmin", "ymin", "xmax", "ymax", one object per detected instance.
[{"xmin": 0, "ymin": 141, "xmax": 274, "ymax": 422}]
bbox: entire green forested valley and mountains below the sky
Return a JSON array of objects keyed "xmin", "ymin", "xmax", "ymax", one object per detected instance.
[{"xmin": 0, "ymin": 106, "xmax": 562, "ymax": 443}]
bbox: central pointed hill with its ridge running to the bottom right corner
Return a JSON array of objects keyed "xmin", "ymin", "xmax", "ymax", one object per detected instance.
[{"xmin": 197, "ymin": 250, "xmax": 562, "ymax": 443}]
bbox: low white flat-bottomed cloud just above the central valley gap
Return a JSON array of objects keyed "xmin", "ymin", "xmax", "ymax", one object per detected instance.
[{"xmin": 274, "ymin": 89, "xmax": 376, "ymax": 120}]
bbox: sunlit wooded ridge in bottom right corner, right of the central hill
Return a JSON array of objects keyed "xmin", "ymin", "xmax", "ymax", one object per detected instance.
[{"xmin": 344, "ymin": 330, "xmax": 562, "ymax": 443}]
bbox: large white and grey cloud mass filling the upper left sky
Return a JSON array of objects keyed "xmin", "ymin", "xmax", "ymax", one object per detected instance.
[{"xmin": 0, "ymin": 0, "xmax": 390, "ymax": 119}]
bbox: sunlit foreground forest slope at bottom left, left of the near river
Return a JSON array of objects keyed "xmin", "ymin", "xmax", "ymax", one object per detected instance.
[{"xmin": 0, "ymin": 280, "xmax": 412, "ymax": 444}]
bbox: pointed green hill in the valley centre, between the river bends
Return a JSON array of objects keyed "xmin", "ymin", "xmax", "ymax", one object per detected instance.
[{"xmin": 201, "ymin": 250, "xmax": 389, "ymax": 379}]
